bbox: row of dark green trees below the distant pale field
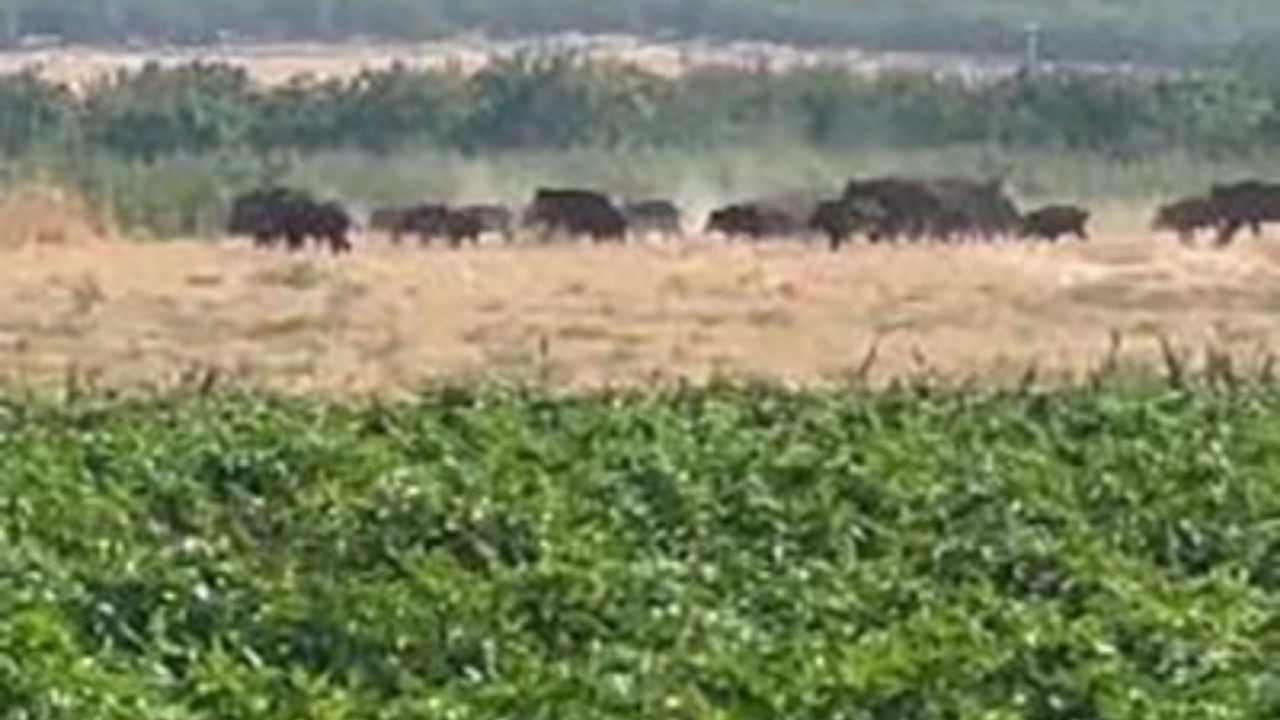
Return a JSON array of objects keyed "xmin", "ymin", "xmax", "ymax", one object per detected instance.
[{"xmin": 0, "ymin": 58, "xmax": 1280, "ymax": 163}]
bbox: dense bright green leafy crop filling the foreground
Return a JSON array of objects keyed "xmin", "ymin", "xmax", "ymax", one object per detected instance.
[{"xmin": 0, "ymin": 388, "xmax": 1280, "ymax": 720}]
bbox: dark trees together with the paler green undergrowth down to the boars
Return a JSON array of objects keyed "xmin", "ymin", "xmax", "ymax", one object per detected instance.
[{"xmin": 0, "ymin": 58, "xmax": 1280, "ymax": 236}]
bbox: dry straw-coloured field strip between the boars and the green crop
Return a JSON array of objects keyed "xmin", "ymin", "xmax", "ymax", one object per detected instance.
[{"xmin": 0, "ymin": 215, "xmax": 1280, "ymax": 393}]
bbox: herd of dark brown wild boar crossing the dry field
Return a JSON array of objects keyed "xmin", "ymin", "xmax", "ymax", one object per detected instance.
[{"xmin": 227, "ymin": 177, "xmax": 1280, "ymax": 254}]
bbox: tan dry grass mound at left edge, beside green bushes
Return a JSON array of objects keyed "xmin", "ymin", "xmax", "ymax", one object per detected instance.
[{"xmin": 0, "ymin": 182, "xmax": 119, "ymax": 249}]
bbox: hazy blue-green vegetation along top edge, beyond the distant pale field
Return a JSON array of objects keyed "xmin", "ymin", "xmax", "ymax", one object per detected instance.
[{"xmin": 0, "ymin": 0, "xmax": 1280, "ymax": 70}]
